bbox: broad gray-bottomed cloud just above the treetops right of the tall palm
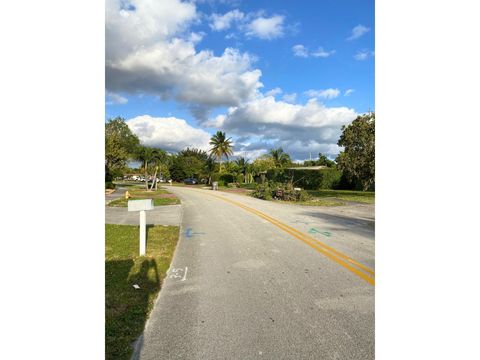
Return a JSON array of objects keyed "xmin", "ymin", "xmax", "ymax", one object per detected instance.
[{"xmin": 211, "ymin": 96, "xmax": 357, "ymax": 159}]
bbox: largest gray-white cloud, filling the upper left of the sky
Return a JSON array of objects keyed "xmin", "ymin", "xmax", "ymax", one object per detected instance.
[{"xmin": 105, "ymin": 0, "xmax": 262, "ymax": 120}]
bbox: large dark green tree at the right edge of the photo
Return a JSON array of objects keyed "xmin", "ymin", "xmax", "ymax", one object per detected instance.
[{"xmin": 336, "ymin": 113, "xmax": 375, "ymax": 191}]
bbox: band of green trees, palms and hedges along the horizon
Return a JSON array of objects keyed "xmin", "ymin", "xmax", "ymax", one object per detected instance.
[{"xmin": 105, "ymin": 113, "xmax": 375, "ymax": 190}]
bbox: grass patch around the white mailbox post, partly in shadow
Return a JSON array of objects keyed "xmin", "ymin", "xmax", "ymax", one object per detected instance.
[{"xmin": 105, "ymin": 225, "xmax": 179, "ymax": 360}]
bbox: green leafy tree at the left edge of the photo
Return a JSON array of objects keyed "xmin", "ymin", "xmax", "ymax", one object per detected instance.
[{"xmin": 105, "ymin": 117, "xmax": 140, "ymax": 178}]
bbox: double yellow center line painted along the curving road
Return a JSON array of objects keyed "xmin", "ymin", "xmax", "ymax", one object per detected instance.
[{"xmin": 203, "ymin": 194, "xmax": 375, "ymax": 285}]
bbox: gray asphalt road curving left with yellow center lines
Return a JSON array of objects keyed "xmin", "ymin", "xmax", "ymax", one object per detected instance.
[{"xmin": 135, "ymin": 187, "xmax": 375, "ymax": 360}]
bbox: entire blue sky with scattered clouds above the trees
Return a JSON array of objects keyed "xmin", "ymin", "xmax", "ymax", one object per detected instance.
[{"xmin": 106, "ymin": 0, "xmax": 375, "ymax": 160}]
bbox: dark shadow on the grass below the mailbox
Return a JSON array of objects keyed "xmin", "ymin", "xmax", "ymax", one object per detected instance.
[{"xmin": 105, "ymin": 258, "xmax": 161, "ymax": 360}]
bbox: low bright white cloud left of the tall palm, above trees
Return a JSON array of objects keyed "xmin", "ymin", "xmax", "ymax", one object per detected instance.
[{"xmin": 127, "ymin": 115, "xmax": 210, "ymax": 152}]
